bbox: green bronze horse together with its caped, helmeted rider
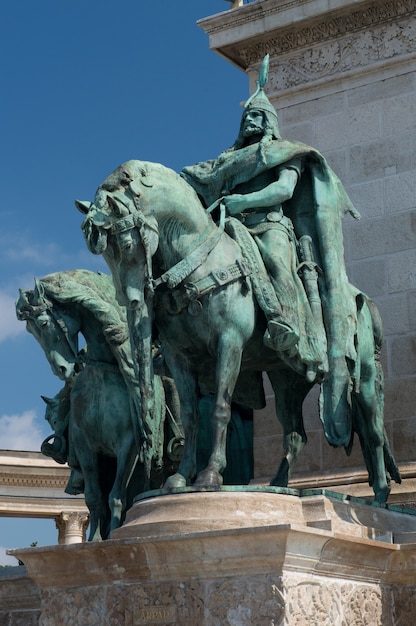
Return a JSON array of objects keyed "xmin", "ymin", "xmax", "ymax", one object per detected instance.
[{"xmin": 76, "ymin": 58, "xmax": 400, "ymax": 502}]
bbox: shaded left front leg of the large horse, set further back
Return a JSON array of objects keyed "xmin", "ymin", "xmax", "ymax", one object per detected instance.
[{"xmin": 163, "ymin": 354, "xmax": 199, "ymax": 491}]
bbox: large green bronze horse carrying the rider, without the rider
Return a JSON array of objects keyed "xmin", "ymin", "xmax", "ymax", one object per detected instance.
[{"xmin": 76, "ymin": 161, "xmax": 400, "ymax": 502}]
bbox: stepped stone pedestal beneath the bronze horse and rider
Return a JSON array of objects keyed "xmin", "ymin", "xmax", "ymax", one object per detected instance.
[{"xmin": 8, "ymin": 487, "xmax": 416, "ymax": 626}]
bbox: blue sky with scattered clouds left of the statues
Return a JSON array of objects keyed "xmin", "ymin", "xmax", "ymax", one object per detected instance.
[{"xmin": 0, "ymin": 0, "xmax": 249, "ymax": 564}]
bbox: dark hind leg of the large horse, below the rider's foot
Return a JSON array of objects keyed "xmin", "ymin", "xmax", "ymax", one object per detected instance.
[{"xmin": 268, "ymin": 369, "xmax": 312, "ymax": 487}]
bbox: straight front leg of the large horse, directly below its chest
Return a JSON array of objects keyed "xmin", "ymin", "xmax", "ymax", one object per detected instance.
[{"xmin": 195, "ymin": 335, "xmax": 242, "ymax": 489}]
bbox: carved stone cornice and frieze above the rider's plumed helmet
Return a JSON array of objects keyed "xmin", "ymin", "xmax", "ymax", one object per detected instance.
[{"xmin": 199, "ymin": 0, "xmax": 416, "ymax": 99}]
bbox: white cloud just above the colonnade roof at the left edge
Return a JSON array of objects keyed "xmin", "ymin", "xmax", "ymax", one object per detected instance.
[{"xmin": 0, "ymin": 410, "xmax": 44, "ymax": 452}]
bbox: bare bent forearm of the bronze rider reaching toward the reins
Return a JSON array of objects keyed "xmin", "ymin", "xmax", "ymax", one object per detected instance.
[{"xmin": 224, "ymin": 168, "xmax": 299, "ymax": 215}]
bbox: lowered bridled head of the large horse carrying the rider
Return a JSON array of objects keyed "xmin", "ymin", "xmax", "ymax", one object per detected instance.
[{"xmin": 75, "ymin": 161, "xmax": 159, "ymax": 311}]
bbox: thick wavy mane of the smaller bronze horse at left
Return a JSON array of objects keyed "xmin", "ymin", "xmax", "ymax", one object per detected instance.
[{"xmin": 38, "ymin": 270, "xmax": 128, "ymax": 335}]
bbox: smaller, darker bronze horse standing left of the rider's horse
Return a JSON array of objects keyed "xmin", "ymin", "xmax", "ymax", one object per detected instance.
[{"xmin": 16, "ymin": 270, "xmax": 183, "ymax": 541}]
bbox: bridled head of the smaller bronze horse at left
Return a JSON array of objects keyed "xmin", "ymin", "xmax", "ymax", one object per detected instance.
[{"xmin": 16, "ymin": 280, "xmax": 78, "ymax": 381}]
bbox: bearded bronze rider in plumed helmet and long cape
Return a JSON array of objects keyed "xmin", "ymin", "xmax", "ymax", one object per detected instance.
[{"xmin": 181, "ymin": 56, "xmax": 359, "ymax": 446}]
